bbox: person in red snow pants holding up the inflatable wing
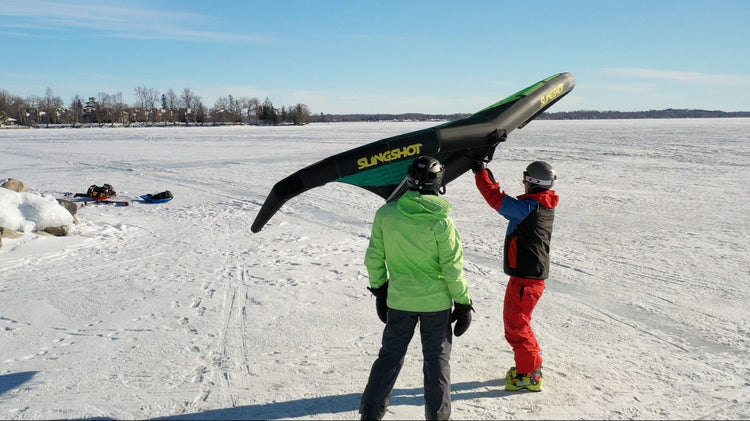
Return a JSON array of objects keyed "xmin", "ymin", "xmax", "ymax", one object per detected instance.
[{"xmin": 472, "ymin": 161, "xmax": 560, "ymax": 390}]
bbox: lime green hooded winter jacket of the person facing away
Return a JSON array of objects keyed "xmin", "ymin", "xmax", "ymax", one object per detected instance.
[{"xmin": 365, "ymin": 191, "xmax": 471, "ymax": 312}]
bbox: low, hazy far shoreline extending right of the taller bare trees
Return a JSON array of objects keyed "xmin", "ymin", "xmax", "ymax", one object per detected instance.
[{"xmin": 310, "ymin": 108, "xmax": 750, "ymax": 123}]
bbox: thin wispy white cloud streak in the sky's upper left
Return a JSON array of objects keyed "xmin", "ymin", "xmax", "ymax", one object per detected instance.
[{"xmin": 0, "ymin": 0, "xmax": 272, "ymax": 43}]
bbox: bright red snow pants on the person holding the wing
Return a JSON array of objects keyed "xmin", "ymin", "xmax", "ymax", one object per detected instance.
[{"xmin": 503, "ymin": 276, "xmax": 544, "ymax": 374}]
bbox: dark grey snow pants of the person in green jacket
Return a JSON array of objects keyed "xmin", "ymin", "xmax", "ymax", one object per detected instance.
[{"xmin": 360, "ymin": 308, "xmax": 453, "ymax": 419}]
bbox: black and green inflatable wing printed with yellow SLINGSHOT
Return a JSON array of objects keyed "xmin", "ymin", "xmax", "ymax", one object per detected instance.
[{"xmin": 251, "ymin": 73, "xmax": 575, "ymax": 232}]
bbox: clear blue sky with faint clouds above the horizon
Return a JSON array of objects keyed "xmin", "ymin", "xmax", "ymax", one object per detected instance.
[{"xmin": 0, "ymin": 0, "xmax": 750, "ymax": 114}]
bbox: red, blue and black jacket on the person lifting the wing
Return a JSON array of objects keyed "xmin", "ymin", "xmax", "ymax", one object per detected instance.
[{"xmin": 474, "ymin": 169, "xmax": 560, "ymax": 279}]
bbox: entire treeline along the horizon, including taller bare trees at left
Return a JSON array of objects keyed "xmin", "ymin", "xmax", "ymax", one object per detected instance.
[{"xmin": 0, "ymin": 82, "xmax": 750, "ymax": 127}]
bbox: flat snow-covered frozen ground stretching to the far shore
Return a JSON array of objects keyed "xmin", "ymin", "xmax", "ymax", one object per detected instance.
[{"xmin": 0, "ymin": 119, "xmax": 750, "ymax": 419}]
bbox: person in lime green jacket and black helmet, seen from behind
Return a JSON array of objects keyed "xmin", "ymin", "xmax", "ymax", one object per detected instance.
[{"xmin": 359, "ymin": 156, "xmax": 473, "ymax": 420}]
